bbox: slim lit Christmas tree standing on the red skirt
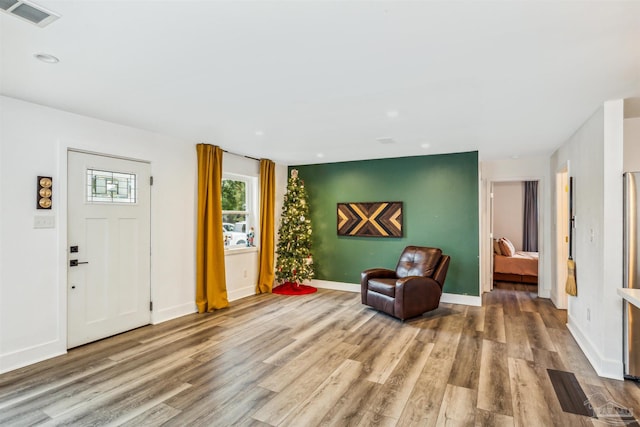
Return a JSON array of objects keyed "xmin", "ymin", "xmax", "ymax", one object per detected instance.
[{"xmin": 276, "ymin": 169, "xmax": 314, "ymax": 287}]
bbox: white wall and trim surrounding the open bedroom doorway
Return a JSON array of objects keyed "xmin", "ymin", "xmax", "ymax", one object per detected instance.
[{"xmin": 480, "ymin": 156, "xmax": 553, "ymax": 298}]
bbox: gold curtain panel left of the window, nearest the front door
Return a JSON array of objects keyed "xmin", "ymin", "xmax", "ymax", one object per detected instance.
[{"xmin": 196, "ymin": 144, "xmax": 229, "ymax": 313}]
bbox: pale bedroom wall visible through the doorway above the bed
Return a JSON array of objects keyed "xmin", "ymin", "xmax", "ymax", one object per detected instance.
[{"xmin": 493, "ymin": 181, "xmax": 524, "ymax": 251}]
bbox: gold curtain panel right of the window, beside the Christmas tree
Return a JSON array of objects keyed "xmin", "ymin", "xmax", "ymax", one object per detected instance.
[{"xmin": 256, "ymin": 159, "xmax": 276, "ymax": 294}]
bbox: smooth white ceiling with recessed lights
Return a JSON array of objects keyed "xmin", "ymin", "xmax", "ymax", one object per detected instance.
[{"xmin": 0, "ymin": 0, "xmax": 640, "ymax": 164}]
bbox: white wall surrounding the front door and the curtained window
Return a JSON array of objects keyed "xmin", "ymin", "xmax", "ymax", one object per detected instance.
[{"xmin": 0, "ymin": 97, "xmax": 286, "ymax": 372}]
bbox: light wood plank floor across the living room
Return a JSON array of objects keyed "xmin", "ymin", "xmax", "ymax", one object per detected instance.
[{"xmin": 0, "ymin": 284, "xmax": 640, "ymax": 426}]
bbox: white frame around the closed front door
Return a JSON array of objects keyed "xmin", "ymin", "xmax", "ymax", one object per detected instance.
[{"xmin": 54, "ymin": 145, "xmax": 154, "ymax": 354}]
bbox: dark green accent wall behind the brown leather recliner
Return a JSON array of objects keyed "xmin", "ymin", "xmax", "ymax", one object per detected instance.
[{"xmin": 289, "ymin": 151, "xmax": 479, "ymax": 296}]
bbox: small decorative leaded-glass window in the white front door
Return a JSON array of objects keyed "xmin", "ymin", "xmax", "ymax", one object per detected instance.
[{"xmin": 87, "ymin": 169, "xmax": 136, "ymax": 204}]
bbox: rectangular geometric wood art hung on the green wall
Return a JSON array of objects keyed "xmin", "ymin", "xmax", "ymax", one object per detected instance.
[{"xmin": 338, "ymin": 202, "xmax": 402, "ymax": 237}]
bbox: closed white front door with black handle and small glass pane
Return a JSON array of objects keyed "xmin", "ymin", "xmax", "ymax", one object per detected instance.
[{"xmin": 67, "ymin": 151, "xmax": 151, "ymax": 348}]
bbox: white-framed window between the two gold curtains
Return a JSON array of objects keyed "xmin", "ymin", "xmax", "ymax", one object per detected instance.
[{"xmin": 222, "ymin": 174, "xmax": 256, "ymax": 249}]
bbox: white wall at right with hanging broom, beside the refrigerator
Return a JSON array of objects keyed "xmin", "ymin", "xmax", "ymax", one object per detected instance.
[{"xmin": 551, "ymin": 100, "xmax": 623, "ymax": 379}]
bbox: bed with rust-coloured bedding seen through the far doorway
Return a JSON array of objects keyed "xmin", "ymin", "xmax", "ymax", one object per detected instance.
[{"xmin": 493, "ymin": 238, "xmax": 538, "ymax": 284}]
